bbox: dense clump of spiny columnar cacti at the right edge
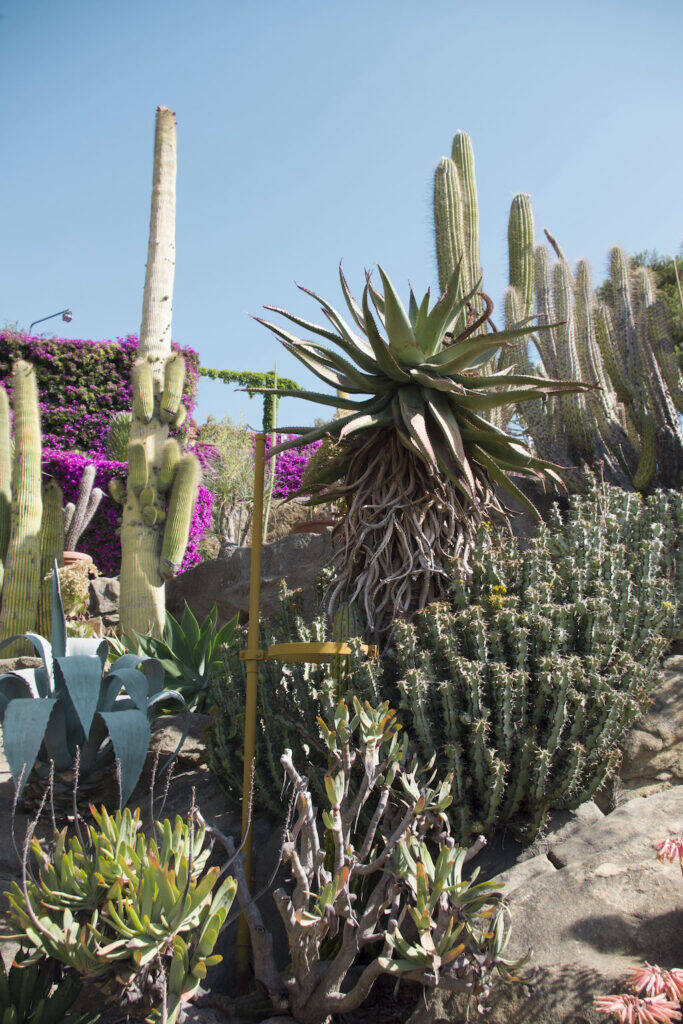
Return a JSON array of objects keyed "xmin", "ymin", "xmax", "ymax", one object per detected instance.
[{"xmin": 499, "ymin": 196, "xmax": 683, "ymax": 490}]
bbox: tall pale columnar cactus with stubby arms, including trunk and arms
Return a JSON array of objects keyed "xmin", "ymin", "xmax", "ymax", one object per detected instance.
[{"xmin": 119, "ymin": 106, "xmax": 200, "ymax": 636}]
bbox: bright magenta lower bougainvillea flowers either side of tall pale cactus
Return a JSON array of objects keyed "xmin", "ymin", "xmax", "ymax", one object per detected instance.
[{"xmin": 43, "ymin": 449, "xmax": 213, "ymax": 575}]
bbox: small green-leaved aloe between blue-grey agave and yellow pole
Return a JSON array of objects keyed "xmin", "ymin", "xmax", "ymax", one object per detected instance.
[{"xmin": 114, "ymin": 602, "xmax": 238, "ymax": 712}]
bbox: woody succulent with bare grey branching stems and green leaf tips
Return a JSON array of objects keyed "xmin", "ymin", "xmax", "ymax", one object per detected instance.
[{"xmin": 229, "ymin": 698, "xmax": 526, "ymax": 1024}]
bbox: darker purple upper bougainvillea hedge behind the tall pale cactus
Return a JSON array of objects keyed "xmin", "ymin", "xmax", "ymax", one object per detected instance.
[{"xmin": 0, "ymin": 331, "xmax": 199, "ymax": 453}]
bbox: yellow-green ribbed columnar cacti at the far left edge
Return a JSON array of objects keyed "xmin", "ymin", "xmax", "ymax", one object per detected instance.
[{"xmin": 0, "ymin": 360, "xmax": 68, "ymax": 655}]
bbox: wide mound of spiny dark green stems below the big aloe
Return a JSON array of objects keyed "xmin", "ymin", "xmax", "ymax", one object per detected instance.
[{"xmin": 209, "ymin": 484, "xmax": 683, "ymax": 842}]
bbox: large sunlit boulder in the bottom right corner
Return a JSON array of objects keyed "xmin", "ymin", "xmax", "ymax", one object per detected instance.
[{"xmin": 410, "ymin": 786, "xmax": 683, "ymax": 1024}]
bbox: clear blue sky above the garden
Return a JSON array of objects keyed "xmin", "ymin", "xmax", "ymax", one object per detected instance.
[{"xmin": 0, "ymin": 0, "xmax": 683, "ymax": 424}]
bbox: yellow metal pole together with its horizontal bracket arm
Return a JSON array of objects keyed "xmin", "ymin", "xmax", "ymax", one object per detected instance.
[{"xmin": 238, "ymin": 434, "xmax": 379, "ymax": 991}]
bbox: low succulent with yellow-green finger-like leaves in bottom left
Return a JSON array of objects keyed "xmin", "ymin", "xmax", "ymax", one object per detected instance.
[{"xmin": 3, "ymin": 808, "xmax": 237, "ymax": 1024}]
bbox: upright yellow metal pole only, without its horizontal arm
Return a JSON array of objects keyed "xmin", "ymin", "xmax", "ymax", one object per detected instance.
[{"xmin": 238, "ymin": 434, "xmax": 265, "ymax": 991}]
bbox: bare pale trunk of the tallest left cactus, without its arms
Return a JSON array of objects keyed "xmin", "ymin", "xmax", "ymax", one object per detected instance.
[{"xmin": 121, "ymin": 106, "xmax": 176, "ymax": 636}]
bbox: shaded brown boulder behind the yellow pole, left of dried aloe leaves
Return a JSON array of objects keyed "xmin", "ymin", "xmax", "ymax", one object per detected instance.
[{"xmin": 166, "ymin": 530, "xmax": 332, "ymax": 623}]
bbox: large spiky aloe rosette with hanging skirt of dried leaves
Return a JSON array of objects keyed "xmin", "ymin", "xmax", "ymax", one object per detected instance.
[{"xmin": 249, "ymin": 264, "xmax": 591, "ymax": 635}]
